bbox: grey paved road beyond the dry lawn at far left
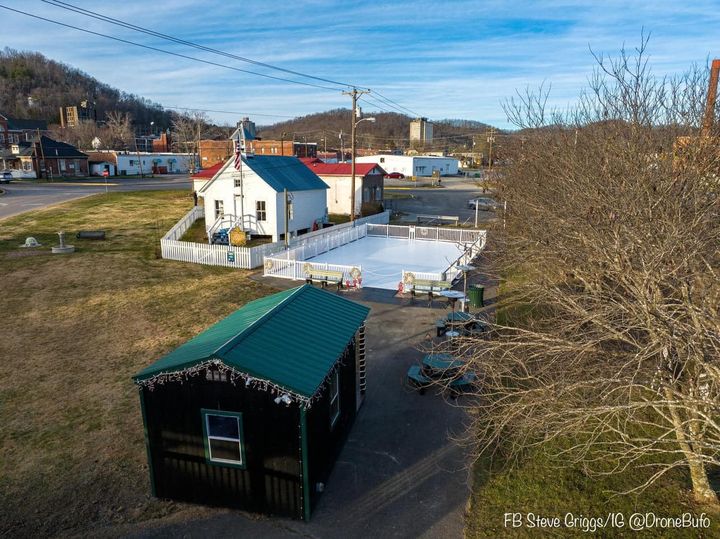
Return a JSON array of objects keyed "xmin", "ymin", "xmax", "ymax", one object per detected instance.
[{"xmin": 0, "ymin": 174, "xmax": 190, "ymax": 219}]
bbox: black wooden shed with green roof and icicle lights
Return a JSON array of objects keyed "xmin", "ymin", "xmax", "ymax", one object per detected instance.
[{"xmin": 134, "ymin": 285, "xmax": 369, "ymax": 520}]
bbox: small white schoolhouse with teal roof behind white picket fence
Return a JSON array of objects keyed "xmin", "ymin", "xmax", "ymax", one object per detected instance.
[{"xmin": 198, "ymin": 154, "xmax": 328, "ymax": 241}]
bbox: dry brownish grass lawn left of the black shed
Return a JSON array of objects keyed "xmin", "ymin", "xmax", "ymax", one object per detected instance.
[{"xmin": 0, "ymin": 191, "xmax": 272, "ymax": 537}]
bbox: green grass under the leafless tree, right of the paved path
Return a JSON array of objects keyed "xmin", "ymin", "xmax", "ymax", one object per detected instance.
[{"xmin": 465, "ymin": 272, "xmax": 720, "ymax": 539}]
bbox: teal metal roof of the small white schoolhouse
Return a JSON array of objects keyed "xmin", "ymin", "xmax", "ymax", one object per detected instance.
[{"xmin": 243, "ymin": 155, "xmax": 328, "ymax": 193}]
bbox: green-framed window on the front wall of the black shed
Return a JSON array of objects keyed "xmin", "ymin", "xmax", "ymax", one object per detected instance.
[{"xmin": 200, "ymin": 409, "xmax": 245, "ymax": 468}]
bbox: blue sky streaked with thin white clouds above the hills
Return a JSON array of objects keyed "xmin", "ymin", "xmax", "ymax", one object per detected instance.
[{"xmin": 0, "ymin": 0, "xmax": 720, "ymax": 127}]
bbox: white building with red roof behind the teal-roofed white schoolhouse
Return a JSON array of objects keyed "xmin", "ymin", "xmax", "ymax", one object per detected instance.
[{"xmin": 301, "ymin": 159, "xmax": 385, "ymax": 215}]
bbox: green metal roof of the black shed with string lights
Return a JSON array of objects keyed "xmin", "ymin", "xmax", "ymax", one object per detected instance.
[{"xmin": 134, "ymin": 285, "xmax": 370, "ymax": 398}]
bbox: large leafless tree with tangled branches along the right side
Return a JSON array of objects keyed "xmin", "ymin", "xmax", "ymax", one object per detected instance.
[{"xmin": 463, "ymin": 38, "xmax": 720, "ymax": 504}]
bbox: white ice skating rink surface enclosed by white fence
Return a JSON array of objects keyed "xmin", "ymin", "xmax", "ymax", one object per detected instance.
[{"xmin": 309, "ymin": 236, "xmax": 462, "ymax": 290}]
